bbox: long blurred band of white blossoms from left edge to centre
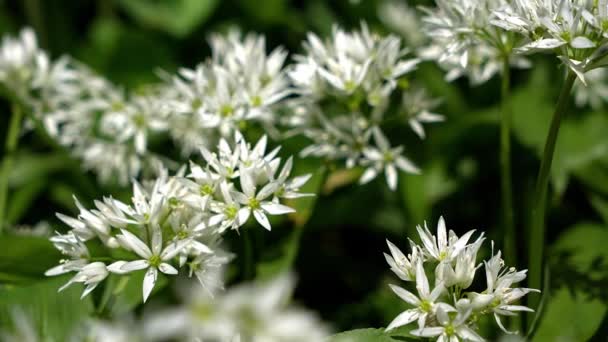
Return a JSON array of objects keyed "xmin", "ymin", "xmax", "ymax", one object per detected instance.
[{"xmin": 0, "ymin": 24, "xmax": 443, "ymax": 189}]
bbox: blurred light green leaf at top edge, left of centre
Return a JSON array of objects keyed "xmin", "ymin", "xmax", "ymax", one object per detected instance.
[{"xmin": 118, "ymin": 0, "xmax": 218, "ymax": 37}]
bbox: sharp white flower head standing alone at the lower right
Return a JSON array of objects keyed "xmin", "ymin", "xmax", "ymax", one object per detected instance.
[{"xmin": 385, "ymin": 217, "xmax": 540, "ymax": 341}]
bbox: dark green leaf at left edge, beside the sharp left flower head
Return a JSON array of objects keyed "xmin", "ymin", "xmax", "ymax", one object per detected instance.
[{"xmin": 0, "ymin": 235, "xmax": 61, "ymax": 282}]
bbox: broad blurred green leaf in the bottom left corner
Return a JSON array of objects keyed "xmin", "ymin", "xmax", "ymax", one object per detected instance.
[{"xmin": 0, "ymin": 276, "xmax": 92, "ymax": 341}]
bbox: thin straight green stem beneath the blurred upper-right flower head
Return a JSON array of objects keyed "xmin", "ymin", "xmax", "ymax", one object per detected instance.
[{"xmin": 500, "ymin": 55, "xmax": 517, "ymax": 265}]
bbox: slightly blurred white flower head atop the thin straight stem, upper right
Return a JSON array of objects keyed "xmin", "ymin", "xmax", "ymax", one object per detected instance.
[{"xmin": 420, "ymin": 0, "xmax": 530, "ymax": 84}]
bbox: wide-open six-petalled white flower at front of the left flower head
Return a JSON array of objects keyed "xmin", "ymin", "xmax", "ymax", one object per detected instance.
[{"xmin": 108, "ymin": 227, "xmax": 189, "ymax": 302}]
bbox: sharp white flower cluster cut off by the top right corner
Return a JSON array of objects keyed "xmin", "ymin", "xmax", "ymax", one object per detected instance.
[{"xmin": 492, "ymin": 0, "xmax": 608, "ymax": 84}]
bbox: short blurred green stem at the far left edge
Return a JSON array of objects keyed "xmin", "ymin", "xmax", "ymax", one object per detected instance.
[{"xmin": 0, "ymin": 104, "xmax": 23, "ymax": 234}]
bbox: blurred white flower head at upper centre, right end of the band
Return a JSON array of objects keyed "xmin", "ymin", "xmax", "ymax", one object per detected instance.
[{"xmin": 287, "ymin": 24, "xmax": 443, "ymax": 190}]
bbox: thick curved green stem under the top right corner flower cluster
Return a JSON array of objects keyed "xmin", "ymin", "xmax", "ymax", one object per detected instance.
[{"xmin": 528, "ymin": 71, "xmax": 576, "ymax": 320}]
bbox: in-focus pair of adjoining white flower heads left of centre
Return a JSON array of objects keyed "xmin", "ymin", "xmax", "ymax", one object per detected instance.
[{"xmin": 46, "ymin": 132, "xmax": 309, "ymax": 301}]
